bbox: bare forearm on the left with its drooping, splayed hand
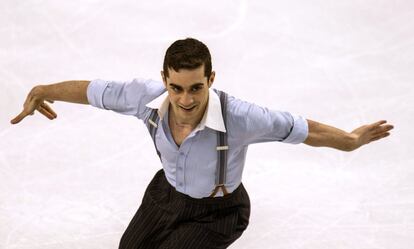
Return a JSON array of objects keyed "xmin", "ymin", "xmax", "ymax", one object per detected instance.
[{"xmin": 10, "ymin": 81, "xmax": 89, "ymax": 124}]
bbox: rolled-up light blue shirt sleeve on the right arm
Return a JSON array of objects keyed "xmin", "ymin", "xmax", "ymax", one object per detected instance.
[{"xmin": 228, "ymin": 97, "xmax": 308, "ymax": 145}]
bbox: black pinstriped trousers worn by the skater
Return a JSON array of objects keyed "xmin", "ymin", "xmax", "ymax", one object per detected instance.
[{"xmin": 119, "ymin": 169, "xmax": 250, "ymax": 249}]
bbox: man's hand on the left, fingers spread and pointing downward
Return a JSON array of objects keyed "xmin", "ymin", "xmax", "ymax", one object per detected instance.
[{"xmin": 10, "ymin": 86, "xmax": 57, "ymax": 124}]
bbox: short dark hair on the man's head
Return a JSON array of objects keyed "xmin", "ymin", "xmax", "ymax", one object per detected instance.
[{"xmin": 163, "ymin": 37, "xmax": 211, "ymax": 79}]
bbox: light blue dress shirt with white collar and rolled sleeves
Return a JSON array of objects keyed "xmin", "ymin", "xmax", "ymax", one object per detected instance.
[{"xmin": 87, "ymin": 78, "xmax": 308, "ymax": 198}]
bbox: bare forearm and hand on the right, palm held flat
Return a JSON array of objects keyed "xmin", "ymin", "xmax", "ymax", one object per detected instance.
[{"xmin": 304, "ymin": 119, "xmax": 394, "ymax": 151}]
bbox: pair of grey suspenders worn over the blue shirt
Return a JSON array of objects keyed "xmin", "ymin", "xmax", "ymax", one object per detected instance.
[{"xmin": 147, "ymin": 89, "xmax": 229, "ymax": 197}]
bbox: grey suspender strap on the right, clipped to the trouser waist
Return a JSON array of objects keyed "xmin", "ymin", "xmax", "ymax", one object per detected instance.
[{"xmin": 210, "ymin": 91, "xmax": 229, "ymax": 197}]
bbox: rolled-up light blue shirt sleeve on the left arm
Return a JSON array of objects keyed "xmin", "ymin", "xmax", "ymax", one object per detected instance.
[{"xmin": 87, "ymin": 78, "xmax": 164, "ymax": 119}]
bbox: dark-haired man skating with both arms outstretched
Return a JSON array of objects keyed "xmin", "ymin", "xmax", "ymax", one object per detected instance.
[{"xmin": 11, "ymin": 38, "xmax": 393, "ymax": 249}]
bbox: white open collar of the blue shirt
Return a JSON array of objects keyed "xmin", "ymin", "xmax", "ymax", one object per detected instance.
[{"xmin": 146, "ymin": 88, "xmax": 226, "ymax": 132}]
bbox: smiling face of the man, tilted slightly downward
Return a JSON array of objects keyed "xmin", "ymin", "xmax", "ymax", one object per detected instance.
[{"xmin": 161, "ymin": 65, "xmax": 215, "ymax": 125}]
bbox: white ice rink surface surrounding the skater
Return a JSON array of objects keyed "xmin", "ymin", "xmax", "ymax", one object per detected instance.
[{"xmin": 0, "ymin": 0, "xmax": 414, "ymax": 249}]
